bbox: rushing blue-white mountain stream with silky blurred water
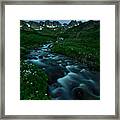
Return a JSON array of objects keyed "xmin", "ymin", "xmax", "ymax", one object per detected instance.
[{"xmin": 27, "ymin": 43, "xmax": 100, "ymax": 100}]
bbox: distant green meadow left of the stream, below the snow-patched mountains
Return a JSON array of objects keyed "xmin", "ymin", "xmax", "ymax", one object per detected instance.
[{"xmin": 20, "ymin": 30, "xmax": 56, "ymax": 59}]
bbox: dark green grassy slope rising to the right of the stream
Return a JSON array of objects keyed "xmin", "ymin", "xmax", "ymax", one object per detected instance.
[{"xmin": 52, "ymin": 21, "xmax": 100, "ymax": 71}]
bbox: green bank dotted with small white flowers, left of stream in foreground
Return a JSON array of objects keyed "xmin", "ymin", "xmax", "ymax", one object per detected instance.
[{"xmin": 20, "ymin": 62, "xmax": 50, "ymax": 100}]
